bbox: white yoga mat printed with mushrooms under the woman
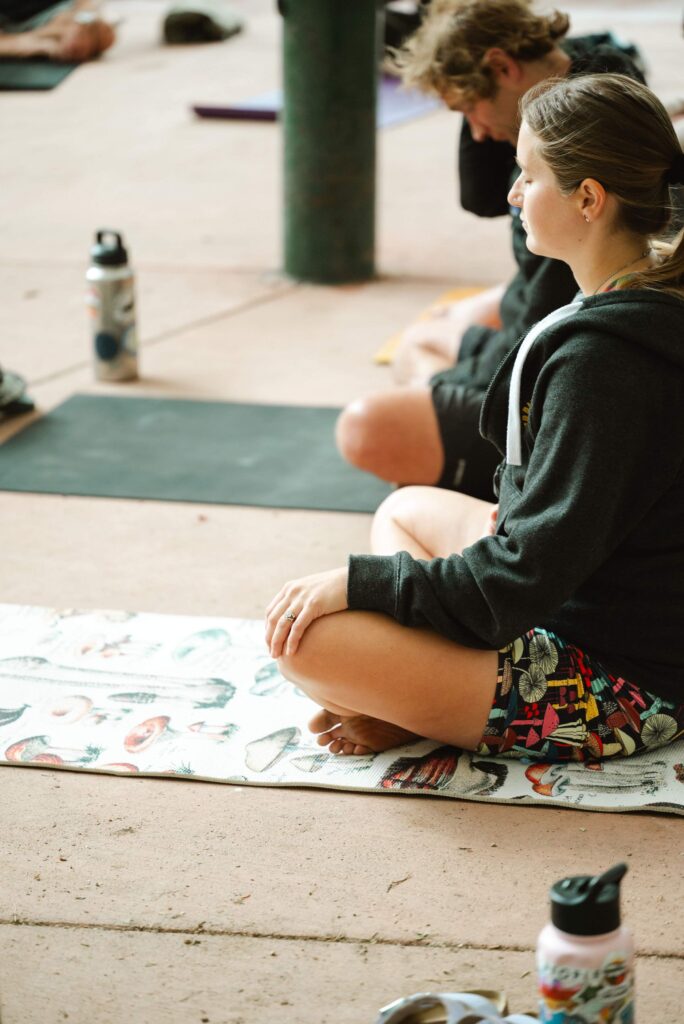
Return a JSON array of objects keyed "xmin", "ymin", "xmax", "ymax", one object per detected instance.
[{"xmin": 0, "ymin": 604, "xmax": 684, "ymax": 814}]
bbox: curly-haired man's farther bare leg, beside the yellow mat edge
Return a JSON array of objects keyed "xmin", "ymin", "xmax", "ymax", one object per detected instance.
[{"xmin": 392, "ymin": 285, "xmax": 504, "ymax": 385}]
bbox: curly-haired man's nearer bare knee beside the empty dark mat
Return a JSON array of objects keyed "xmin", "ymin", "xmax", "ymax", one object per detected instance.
[{"xmin": 336, "ymin": 387, "xmax": 444, "ymax": 484}]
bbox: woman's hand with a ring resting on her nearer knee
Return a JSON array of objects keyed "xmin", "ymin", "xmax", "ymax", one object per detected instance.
[{"xmin": 266, "ymin": 567, "xmax": 348, "ymax": 657}]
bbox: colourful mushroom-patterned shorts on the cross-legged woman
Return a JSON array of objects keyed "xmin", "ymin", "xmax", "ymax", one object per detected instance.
[{"xmin": 477, "ymin": 629, "xmax": 684, "ymax": 761}]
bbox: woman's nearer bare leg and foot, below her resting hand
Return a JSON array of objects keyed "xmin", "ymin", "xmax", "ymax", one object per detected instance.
[{"xmin": 280, "ymin": 611, "xmax": 497, "ymax": 753}]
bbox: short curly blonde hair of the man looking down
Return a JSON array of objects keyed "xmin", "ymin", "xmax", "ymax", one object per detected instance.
[{"xmin": 392, "ymin": 0, "xmax": 570, "ymax": 102}]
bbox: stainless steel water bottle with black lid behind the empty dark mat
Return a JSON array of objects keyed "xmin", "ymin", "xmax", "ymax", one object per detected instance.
[{"xmin": 86, "ymin": 229, "xmax": 138, "ymax": 381}]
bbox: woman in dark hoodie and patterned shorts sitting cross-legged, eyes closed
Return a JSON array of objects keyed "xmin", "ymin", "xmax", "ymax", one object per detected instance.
[{"xmin": 266, "ymin": 75, "xmax": 684, "ymax": 761}]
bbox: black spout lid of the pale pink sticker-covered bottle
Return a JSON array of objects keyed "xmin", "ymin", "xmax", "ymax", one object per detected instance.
[{"xmin": 551, "ymin": 864, "xmax": 627, "ymax": 935}]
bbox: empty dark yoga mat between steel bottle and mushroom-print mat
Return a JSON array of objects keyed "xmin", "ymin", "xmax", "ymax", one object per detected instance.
[{"xmin": 0, "ymin": 394, "xmax": 390, "ymax": 512}]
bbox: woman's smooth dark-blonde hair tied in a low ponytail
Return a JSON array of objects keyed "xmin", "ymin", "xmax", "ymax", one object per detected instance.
[{"xmin": 520, "ymin": 74, "xmax": 684, "ymax": 295}]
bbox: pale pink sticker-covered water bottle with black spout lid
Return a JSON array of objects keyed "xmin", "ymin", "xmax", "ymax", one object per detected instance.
[{"xmin": 537, "ymin": 864, "xmax": 635, "ymax": 1024}]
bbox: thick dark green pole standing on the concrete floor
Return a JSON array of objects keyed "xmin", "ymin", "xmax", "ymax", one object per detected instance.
[{"xmin": 279, "ymin": 0, "xmax": 384, "ymax": 284}]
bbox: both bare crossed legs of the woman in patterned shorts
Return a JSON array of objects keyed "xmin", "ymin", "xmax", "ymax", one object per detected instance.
[{"xmin": 281, "ymin": 487, "xmax": 497, "ymax": 755}]
